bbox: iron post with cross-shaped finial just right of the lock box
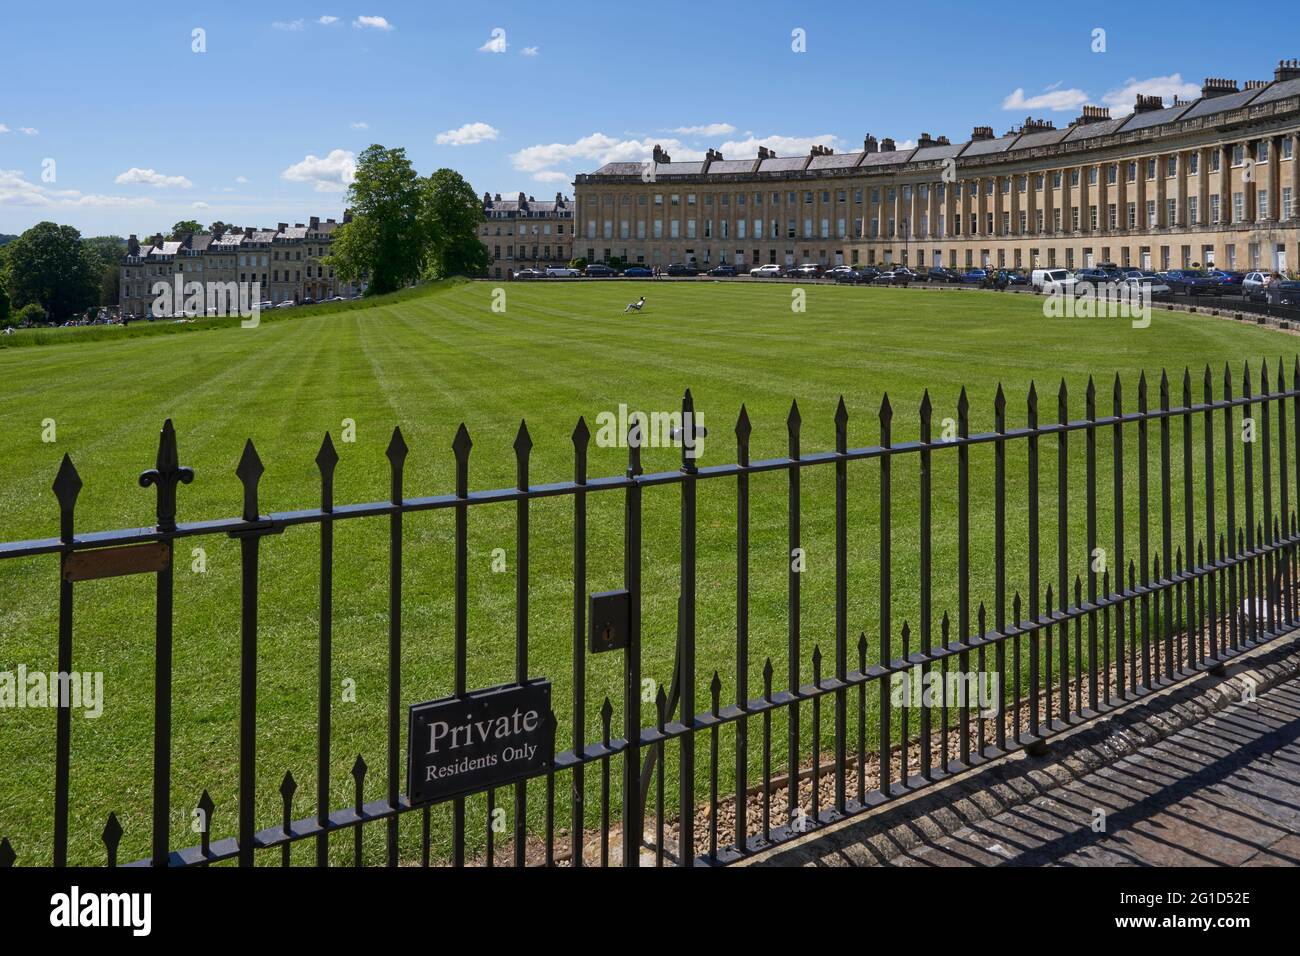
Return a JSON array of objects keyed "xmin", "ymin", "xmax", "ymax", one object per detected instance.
[{"xmin": 677, "ymin": 389, "xmax": 696, "ymax": 866}]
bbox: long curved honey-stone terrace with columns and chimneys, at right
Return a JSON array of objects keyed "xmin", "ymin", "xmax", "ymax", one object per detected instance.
[{"xmin": 573, "ymin": 60, "xmax": 1300, "ymax": 277}]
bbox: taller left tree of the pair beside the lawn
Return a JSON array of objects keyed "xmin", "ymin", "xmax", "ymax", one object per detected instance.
[{"xmin": 325, "ymin": 143, "xmax": 425, "ymax": 295}]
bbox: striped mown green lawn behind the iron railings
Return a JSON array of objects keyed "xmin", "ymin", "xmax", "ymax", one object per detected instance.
[{"xmin": 0, "ymin": 282, "xmax": 1296, "ymax": 864}]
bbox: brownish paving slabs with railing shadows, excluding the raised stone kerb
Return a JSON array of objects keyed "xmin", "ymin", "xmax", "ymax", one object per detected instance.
[{"xmin": 893, "ymin": 679, "xmax": 1300, "ymax": 866}]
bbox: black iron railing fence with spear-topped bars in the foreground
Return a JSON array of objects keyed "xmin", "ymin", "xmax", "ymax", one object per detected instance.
[{"xmin": 0, "ymin": 358, "xmax": 1300, "ymax": 866}]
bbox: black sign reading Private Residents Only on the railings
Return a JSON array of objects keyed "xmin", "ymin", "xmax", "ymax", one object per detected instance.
[{"xmin": 407, "ymin": 678, "xmax": 555, "ymax": 804}]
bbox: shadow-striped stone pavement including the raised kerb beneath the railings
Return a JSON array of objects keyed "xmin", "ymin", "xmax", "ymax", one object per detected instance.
[{"xmin": 758, "ymin": 645, "xmax": 1300, "ymax": 866}]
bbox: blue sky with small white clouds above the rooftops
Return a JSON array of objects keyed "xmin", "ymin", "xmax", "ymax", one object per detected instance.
[{"xmin": 0, "ymin": 0, "xmax": 1300, "ymax": 235}]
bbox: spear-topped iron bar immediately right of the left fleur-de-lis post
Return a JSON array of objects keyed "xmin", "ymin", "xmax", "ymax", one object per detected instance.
[{"xmin": 235, "ymin": 438, "xmax": 264, "ymax": 866}]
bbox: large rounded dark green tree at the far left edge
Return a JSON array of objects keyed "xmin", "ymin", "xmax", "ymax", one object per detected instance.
[{"xmin": 5, "ymin": 222, "xmax": 100, "ymax": 321}]
